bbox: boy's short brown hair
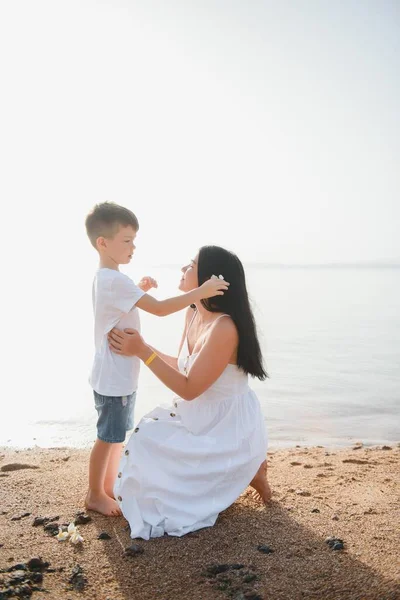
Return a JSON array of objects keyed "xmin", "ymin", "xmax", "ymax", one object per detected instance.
[{"xmin": 85, "ymin": 202, "xmax": 139, "ymax": 248}]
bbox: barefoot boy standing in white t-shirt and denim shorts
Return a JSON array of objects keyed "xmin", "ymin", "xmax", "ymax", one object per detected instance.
[{"xmin": 85, "ymin": 202, "xmax": 229, "ymax": 516}]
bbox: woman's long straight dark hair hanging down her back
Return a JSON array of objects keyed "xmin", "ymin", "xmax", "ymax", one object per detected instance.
[{"xmin": 197, "ymin": 246, "xmax": 268, "ymax": 381}]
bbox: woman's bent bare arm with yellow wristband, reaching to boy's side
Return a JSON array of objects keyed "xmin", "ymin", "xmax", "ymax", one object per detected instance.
[{"xmin": 109, "ymin": 319, "xmax": 238, "ymax": 400}]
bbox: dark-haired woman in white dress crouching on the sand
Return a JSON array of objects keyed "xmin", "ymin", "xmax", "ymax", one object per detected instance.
[{"xmin": 109, "ymin": 246, "xmax": 271, "ymax": 539}]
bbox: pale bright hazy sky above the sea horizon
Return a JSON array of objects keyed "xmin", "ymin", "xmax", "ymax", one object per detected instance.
[{"xmin": 0, "ymin": 0, "xmax": 400, "ymax": 272}]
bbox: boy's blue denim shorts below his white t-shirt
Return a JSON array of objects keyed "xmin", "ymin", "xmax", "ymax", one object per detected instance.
[{"xmin": 93, "ymin": 390, "xmax": 136, "ymax": 444}]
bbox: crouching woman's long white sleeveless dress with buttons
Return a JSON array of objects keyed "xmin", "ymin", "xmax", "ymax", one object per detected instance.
[{"xmin": 114, "ymin": 316, "xmax": 267, "ymax": 540}]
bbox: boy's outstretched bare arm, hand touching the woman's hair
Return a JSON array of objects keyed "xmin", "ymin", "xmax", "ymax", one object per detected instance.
[{"xmin": 136, "ymin": 279, "xmax": 229, "ymax": 317}]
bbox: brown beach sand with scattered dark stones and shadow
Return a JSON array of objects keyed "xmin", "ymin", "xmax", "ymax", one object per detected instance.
[{"xmin": 0, "ymin": 444, "xmax": 400, "ymax": 600}]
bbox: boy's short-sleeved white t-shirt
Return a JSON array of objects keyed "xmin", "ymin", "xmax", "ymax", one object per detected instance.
[{"xmin": 89, "ymin": 269, "xmax": 144, "ymax": 396}]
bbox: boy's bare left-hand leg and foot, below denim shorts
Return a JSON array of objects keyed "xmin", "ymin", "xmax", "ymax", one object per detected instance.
[{"xmin": 85, "ymin": 439, "xmax": 121, "ymax": 517}]
